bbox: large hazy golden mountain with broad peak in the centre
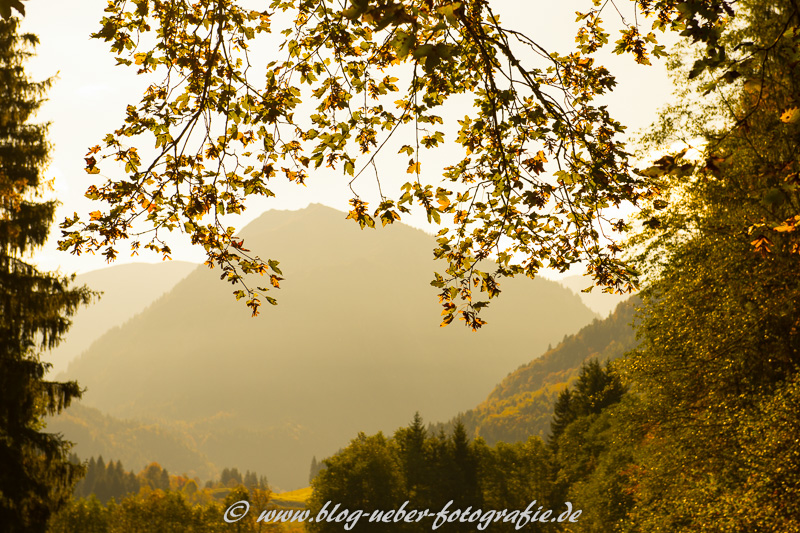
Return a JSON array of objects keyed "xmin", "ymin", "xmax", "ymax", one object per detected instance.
[{"xmin": 59, "ymin": 205, "xmax": 596, "ymax": 489}]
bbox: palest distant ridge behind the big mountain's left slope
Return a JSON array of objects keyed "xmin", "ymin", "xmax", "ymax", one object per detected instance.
[{"xmin": 43, "ymin": 261, "xmax": 197, "ymax": 374}]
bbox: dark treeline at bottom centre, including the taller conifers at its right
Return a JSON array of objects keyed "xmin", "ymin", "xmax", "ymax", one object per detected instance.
[{"xmin": 308, "ymin": 360, "xmax": 626, "ymax": 533}]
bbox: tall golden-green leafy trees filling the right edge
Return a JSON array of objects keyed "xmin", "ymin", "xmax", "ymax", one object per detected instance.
[{"xmin": 616, "ymin": 0, "xmax": 800, "ymax": 532}]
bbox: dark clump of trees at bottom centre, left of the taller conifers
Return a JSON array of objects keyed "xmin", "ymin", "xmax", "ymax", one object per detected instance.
[{"xmin": 308, "ymin": 415, "xmax": 552, "ymax": 532}]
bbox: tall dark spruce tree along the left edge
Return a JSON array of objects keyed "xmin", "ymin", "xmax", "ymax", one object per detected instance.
[{"xmin": 0, "ymin": 15, "xmax": 91, "ymax": 532}]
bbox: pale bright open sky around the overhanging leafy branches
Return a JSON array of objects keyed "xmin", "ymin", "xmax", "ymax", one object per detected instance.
[{"xmin": 17, "ymin": 0, "xmax": 672, "ymax": 273}]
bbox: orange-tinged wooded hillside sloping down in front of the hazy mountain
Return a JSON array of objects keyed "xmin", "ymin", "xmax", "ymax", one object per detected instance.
[{"xmin": 433, "ymin": 296, "xmax": 639, "ymax": 445}]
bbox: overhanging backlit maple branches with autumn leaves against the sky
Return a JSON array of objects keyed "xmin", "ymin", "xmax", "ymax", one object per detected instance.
[{"xmin": 54, "ymin": 0, "xmax": 744, "ymax": 329}]
